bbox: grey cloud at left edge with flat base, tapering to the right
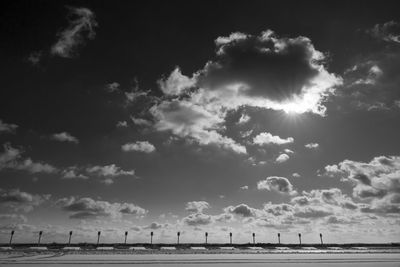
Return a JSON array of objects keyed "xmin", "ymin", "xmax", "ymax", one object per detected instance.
[{"xmin": 0, "ymin": 143, "xmax": 58, "ymax": 173}]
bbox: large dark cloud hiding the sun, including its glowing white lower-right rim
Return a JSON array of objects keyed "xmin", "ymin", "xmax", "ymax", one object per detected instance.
[{"xmin": 198, "ymin": 30, "xmax": 341, "ymax": 114}]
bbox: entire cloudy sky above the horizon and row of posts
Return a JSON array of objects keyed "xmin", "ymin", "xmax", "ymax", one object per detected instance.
[{"xmin": 0, "ymin": 0, "xmax": 400, "ymax": 246}]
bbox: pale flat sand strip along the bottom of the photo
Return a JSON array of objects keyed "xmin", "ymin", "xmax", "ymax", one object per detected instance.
[{"xmin": 0, "ymin": 252, "xmax": 400, "ymax": 267}]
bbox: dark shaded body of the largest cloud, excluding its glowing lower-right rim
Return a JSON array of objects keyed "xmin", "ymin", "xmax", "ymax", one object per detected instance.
[{"xmin": 199, "ymin": 30, "xmax": 324, "ymax": 101}]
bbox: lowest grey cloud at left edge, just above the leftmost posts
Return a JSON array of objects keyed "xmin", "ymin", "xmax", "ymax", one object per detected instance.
[{"xmin": 0, "ymin": 188, "xmax": 50, "ymax": 212}]
